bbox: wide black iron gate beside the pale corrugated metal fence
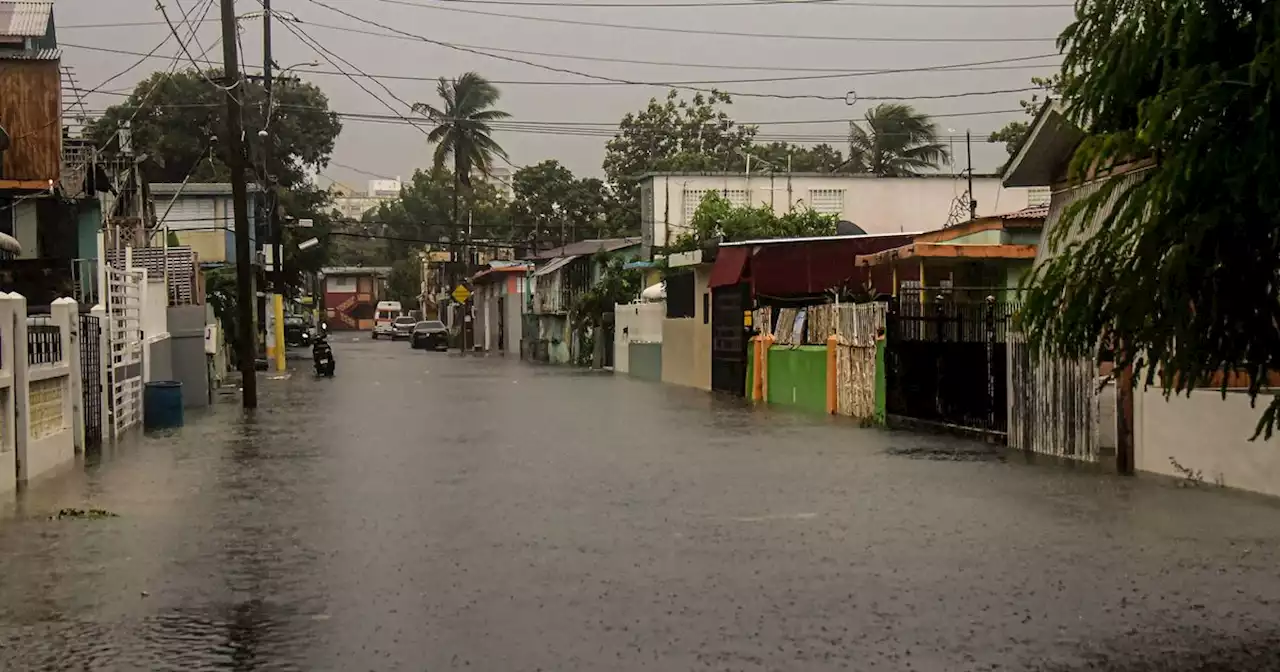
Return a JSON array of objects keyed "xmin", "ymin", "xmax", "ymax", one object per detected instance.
[{"xmin": 884, "ymin": 296, "xmax": 1012, "ymax": 435}]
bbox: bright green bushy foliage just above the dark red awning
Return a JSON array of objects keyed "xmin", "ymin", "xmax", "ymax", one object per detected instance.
[{"xmin": 669, "ymin": 192, "xmax": 838, "ymax": 252}]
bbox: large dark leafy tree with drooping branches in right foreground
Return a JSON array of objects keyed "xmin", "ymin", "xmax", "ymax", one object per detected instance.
[{"xmin": 1023, "ymin": 0, "xmax": 1280, "ymax": 436}]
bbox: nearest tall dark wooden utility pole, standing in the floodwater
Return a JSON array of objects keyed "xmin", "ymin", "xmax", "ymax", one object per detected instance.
[{"xmin": 221, "ymin": 0, "xmax": 257, "ymax": 408}]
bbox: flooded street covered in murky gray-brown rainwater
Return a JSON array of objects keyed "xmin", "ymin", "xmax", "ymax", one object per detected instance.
[{"xmin": 0, "ymin": 338, "xmax": 1280, "ymax": 671}]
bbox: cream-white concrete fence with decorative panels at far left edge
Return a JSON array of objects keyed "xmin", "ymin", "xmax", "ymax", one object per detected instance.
[{"xmin": 0, "ymin": 292, "xmax": 84, "ymax": 493}]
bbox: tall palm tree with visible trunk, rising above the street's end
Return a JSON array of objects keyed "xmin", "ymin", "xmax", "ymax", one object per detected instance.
[{"xmin": 413, "ymin": 72, "xmax": 511, "ymax": 261}]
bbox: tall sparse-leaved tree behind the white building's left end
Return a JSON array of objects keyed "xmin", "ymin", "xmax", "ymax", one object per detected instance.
[{"xmin": 604, "ymin": 90, "xmax": 756, "ymax": 232}]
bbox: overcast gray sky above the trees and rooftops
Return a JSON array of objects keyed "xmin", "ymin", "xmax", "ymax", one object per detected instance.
[{"xmin": 55, "ymin": 0, "xmax": 1071, "ymax": 188}]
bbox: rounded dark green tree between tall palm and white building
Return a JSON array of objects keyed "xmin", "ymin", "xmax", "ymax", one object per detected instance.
[{"xmin": 511, "ymin": 159, "xmax": 609, "ymax": 248}]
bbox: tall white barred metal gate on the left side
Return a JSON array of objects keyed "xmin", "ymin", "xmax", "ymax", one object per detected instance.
[{"xmin": 105, "ymin": 266, "xmax": 147, "ymax": 439}]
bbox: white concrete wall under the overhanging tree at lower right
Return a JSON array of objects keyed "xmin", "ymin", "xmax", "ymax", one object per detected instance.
[{"xmin": 1134, "ymin": 389, "xmax": 1280, "ymax": 495}]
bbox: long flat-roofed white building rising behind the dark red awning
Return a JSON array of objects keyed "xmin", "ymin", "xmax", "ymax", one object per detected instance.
[{"xmin": 640, "ymin": 173, "xmax": 1048, "ymax": 250}]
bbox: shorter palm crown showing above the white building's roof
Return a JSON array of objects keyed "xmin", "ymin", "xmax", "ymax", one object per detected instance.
[{"xmin": 844, "ymin": 102, "xmax": 950, "ymax": 178}]
